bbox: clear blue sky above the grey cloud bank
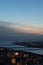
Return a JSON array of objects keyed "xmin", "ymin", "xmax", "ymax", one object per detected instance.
[{"xmin": 0, "ymin": 0, "xmax": 43, "ymax": 27}]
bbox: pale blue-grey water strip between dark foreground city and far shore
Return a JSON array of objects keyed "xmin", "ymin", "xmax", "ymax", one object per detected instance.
[{"xmin": 0, "ymin": 43, "xmax": 43, "ymax": 55}]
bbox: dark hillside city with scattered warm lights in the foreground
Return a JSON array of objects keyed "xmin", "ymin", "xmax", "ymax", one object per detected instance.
[{"xmin": 0, "ymin": 47, "xmax": 43, "ymax": 65}]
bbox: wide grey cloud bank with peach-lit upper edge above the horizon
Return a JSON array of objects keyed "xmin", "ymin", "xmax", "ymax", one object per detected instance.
[{"xmin": 0, "ymin": 21, "xmax": 43, "ymax": 41}]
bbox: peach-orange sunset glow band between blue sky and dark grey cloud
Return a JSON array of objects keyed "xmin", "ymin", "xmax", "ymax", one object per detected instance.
[{"xmin": 9, "ymin": 25, "xmax": 43, "ymax": 35}]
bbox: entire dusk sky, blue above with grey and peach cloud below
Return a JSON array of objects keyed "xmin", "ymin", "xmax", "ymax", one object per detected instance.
[{"xmin": 0, "ymin": 0, "xmax": 43, "ymax": 41}]
